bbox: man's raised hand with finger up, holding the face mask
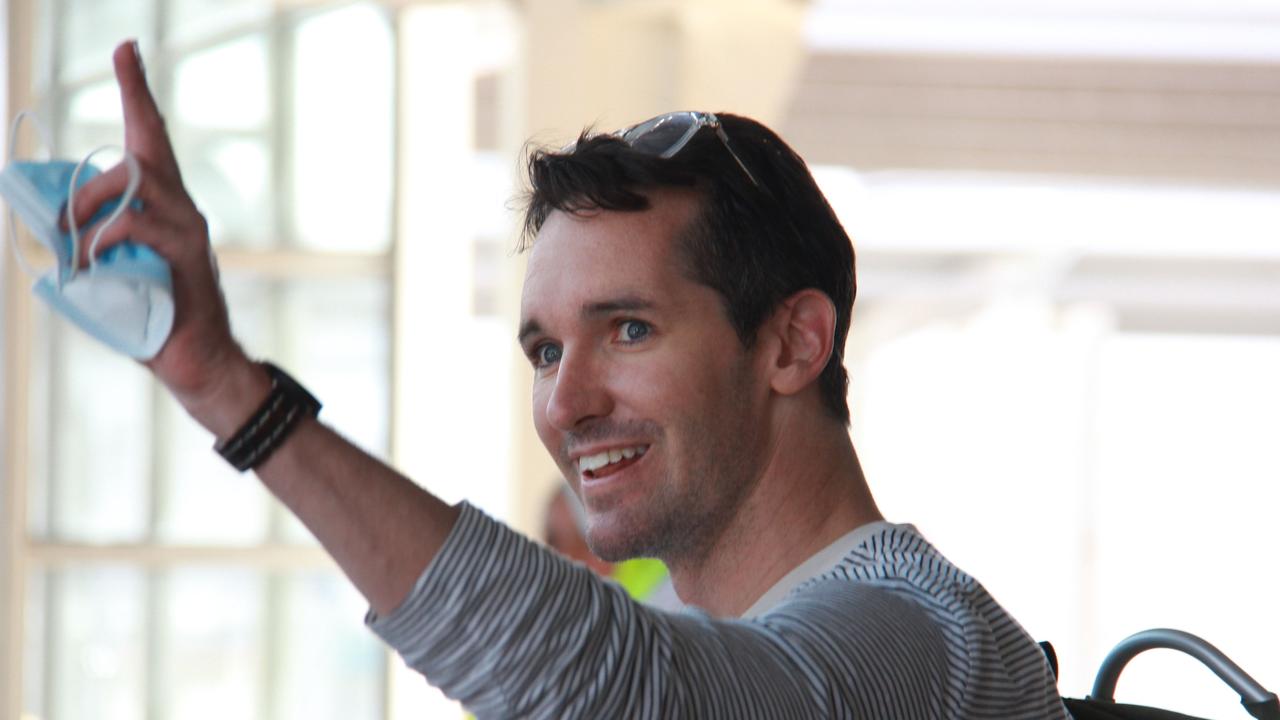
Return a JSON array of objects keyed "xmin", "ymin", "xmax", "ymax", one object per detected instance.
[{"xmin": 72, "ymin": 42, "xmax": 270, "ymax": 438}]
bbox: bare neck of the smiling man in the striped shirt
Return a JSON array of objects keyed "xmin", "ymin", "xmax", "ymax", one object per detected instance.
[{"xmin": 666, "ymin": 412, "xmax": 883, "ymax": 618}]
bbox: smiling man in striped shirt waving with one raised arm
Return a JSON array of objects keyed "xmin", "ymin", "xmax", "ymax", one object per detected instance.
[{"xmin": 73, "ymin": 45, "xmax": 1065, "ymax": 717}]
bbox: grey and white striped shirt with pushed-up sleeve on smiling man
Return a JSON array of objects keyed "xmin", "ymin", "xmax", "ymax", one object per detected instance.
[{"xmin": 366, "ymin": 503, "xmax": 1068, "ymax": 719}]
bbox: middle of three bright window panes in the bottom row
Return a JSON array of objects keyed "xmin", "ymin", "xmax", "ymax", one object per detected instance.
[{"xmin": 162, "ymin": 568, "xmax": 265, "ymax": 720}]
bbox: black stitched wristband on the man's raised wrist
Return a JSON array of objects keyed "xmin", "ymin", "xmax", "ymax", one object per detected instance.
[{"xmin": 214, "ymin": 363, "xmax": 320, "ymax": 473}]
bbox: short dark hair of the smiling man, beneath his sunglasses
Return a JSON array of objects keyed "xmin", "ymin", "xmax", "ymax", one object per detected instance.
[{"xmin": 520, "ymin": 114, "xmax": 858, "ymax": 424}]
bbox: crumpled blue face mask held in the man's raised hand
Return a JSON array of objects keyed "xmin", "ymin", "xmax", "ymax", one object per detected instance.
[{"xmin": 0, "ymin": 113, "xmax": 173, "ymax": 360}]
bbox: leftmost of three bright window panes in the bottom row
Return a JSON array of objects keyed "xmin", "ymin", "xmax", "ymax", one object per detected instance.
[{"xmin": 45, "ymin": 566, "xmax": 146, "ymax": 720}]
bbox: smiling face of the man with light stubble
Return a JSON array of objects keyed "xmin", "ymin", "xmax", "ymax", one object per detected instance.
[{"xmin": 520, "ymin": 192, "xmax": 768, "ymax": 560}]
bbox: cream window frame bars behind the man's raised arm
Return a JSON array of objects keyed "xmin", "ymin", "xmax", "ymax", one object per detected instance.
[{"xmin": 0, "ymin": 0, "xmax": 399, "ymax": 719}]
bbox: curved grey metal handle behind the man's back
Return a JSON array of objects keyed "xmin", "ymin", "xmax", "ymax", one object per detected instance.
[{"xmin": 1089, "ymin": 628, "xmax": 1280, "ymax": 720}]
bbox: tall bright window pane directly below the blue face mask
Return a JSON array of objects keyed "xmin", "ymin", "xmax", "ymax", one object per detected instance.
[{"xmin": 45, "ymin": 319, "xmax": 155, "ymax": 542}]
